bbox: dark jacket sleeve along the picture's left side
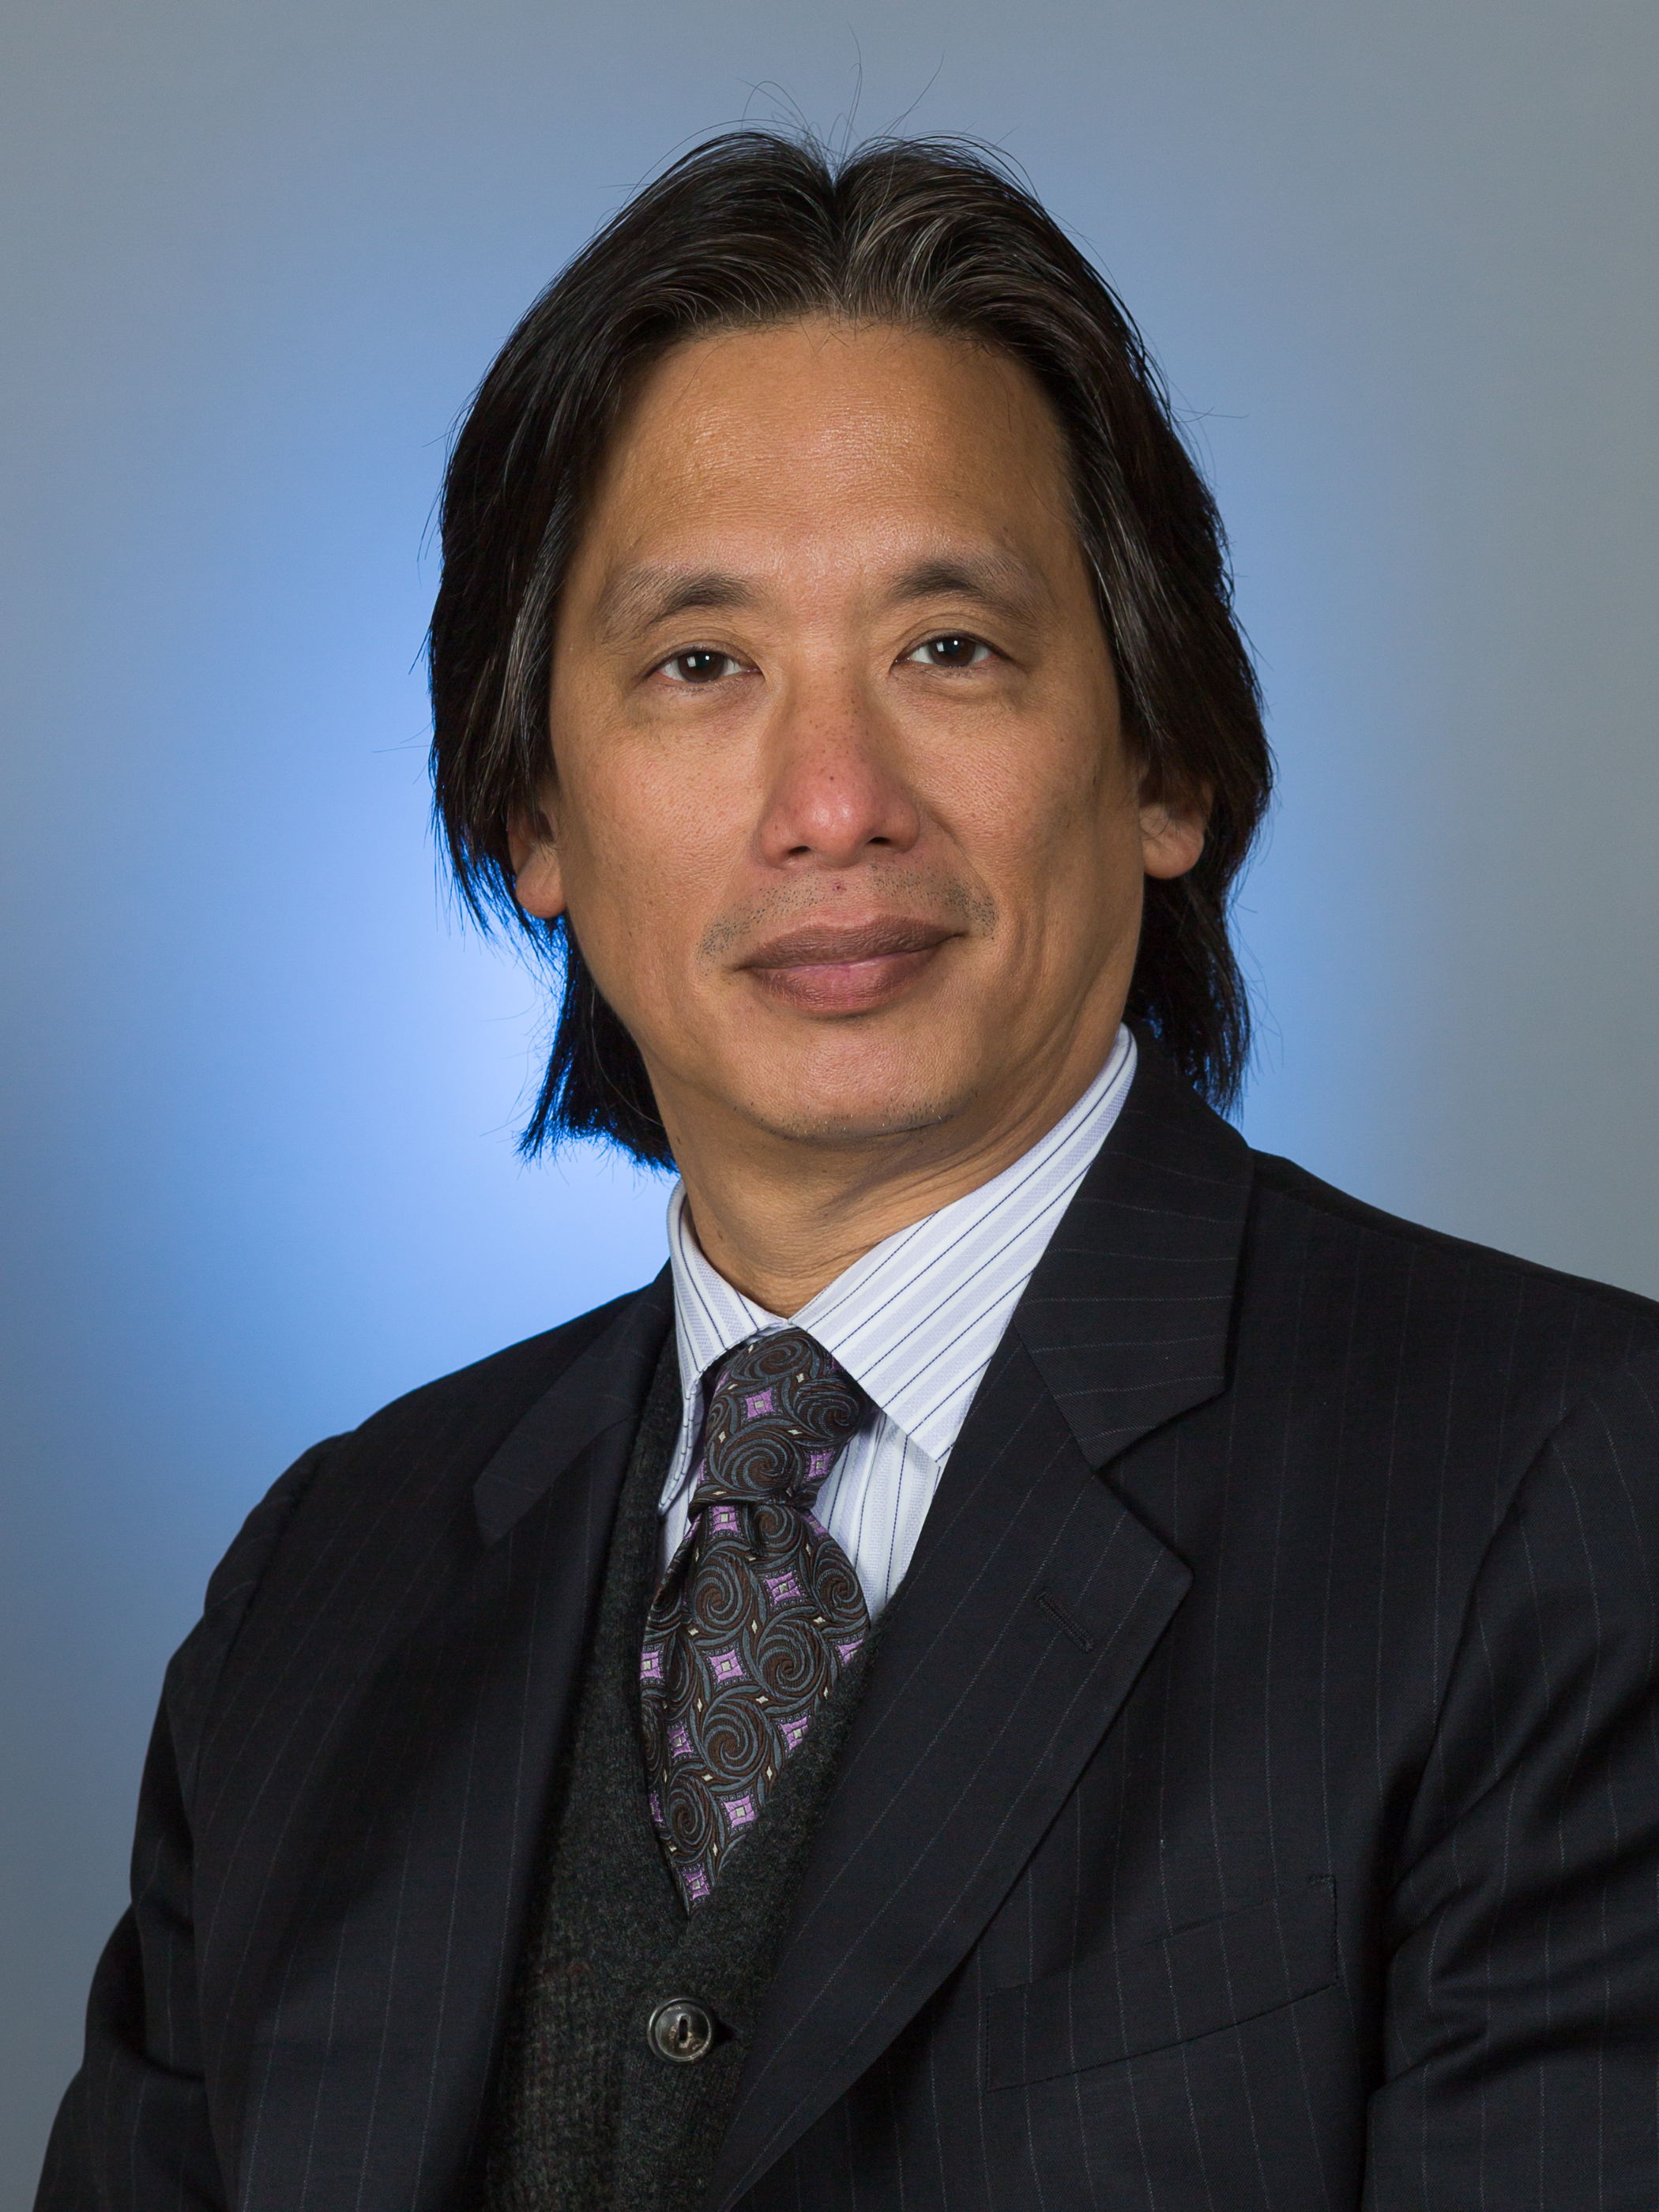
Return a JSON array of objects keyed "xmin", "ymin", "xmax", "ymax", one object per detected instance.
[{"xmin": 36, "ymin": 1444, "xmax": 338, "ymax": 2212}]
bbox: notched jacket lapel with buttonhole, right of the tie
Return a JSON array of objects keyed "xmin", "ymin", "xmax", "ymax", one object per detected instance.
[{"xmin": 708, "ymin": 1040, "xmax": 1250, "ymax": 2212}]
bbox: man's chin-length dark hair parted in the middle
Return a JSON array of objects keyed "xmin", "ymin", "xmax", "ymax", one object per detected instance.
[{"xmin": 429, "ymin": 130, "xmax": 1272, "ymax": 1164}]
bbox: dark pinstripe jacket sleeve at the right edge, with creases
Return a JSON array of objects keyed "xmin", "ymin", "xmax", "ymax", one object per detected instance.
[{"xmin": 1365, "ymin": 1358, "xmax": 1659, "ymax": 2212}]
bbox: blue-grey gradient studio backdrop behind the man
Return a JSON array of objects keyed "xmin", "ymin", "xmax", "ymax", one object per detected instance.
[{"xmin": 0, "ymin": 0, "xmax": 1659, "ymax": 2176}]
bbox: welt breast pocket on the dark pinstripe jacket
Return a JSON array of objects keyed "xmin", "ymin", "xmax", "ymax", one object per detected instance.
[{"xmin": 984, "ymin": 1880, "xmax": 1336, "ymax": 2090}]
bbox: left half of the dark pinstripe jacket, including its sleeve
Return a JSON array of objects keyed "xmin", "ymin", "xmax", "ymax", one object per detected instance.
[{"xmin": 42, "ymin": 1281, "xmax": 670, "ymax": 2212}]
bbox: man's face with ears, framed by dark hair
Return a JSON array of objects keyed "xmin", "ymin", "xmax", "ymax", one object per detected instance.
[{"xmin": 514, "ymin": 323, "xmax": 1201, "ymax": 1159}]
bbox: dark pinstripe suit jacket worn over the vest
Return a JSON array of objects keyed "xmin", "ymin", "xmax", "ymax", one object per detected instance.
[{"xmin": 42, "ymin": 1051, "xmax": 1659, "ymax": 2212}]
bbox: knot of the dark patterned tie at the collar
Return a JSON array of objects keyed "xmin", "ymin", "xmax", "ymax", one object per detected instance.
[{"xmin": 694, "ymin": 1330, "xmax": 869, "ymax": 1504}]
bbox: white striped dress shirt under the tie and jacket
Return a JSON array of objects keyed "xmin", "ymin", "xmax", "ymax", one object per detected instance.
[{"xmin": 659, "ymin": 1029, "xmax": 1134, "ymax": 1621}]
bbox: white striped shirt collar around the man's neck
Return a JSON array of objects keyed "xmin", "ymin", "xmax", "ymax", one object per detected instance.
[{"xmin": 668, "ymin": 1029, "xmax": 1134, "ymax": 1460}]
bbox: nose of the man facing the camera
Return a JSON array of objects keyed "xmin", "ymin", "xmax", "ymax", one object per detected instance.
[{"xmin": 757, "ymin": 672, "xmax": 923, "ymax": 871}]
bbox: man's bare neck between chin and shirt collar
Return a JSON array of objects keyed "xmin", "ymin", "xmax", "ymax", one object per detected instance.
[{"xmin": 670, "ymin": 1024, "xmax": 1115, "ymax": 1319}]
